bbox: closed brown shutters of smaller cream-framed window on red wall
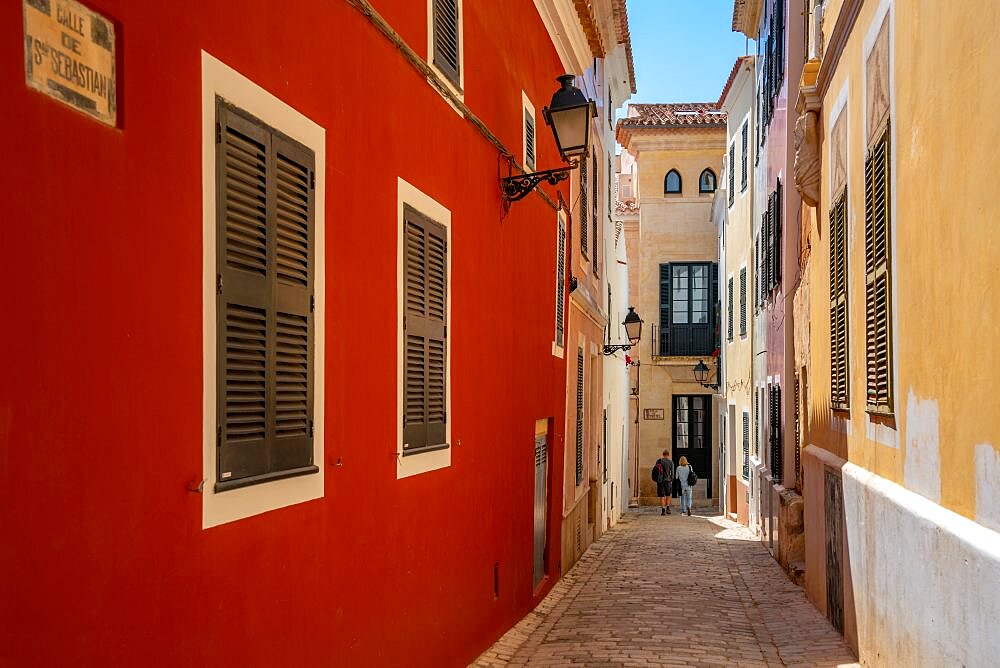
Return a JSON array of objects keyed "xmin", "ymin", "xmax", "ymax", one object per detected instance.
[{"xmin": 403, "ymin": 206, "xmax": 448, "ymax": 455}]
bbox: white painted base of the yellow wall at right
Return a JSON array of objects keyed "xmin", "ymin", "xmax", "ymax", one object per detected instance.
[{"xmin": 843, "ymin": 464, "xmax": 1000, "ymax": 667}]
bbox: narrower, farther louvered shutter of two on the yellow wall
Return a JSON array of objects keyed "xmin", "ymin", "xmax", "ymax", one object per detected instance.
[{"xmin": 830, "ymin": 189, "xmax": 850, "ymax": 410}]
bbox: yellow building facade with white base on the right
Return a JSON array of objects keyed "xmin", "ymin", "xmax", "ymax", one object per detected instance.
[{"xmin": 794, "ymin": 0, "xmax": 1000, "ymax": 665}]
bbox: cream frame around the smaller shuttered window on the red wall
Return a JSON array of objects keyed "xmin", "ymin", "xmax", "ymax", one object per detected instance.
[{"xmin": 396, "ymin": 177, "xmax": 454, "ymax": 480}]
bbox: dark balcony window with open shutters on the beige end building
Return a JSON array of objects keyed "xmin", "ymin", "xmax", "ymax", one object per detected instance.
[{"xmin": 659, "ymin": 262, "xmax": 719, "ymax": 356}]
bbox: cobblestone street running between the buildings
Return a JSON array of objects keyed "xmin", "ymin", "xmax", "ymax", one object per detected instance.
[{"xmin": 474, "ymin": 508, "xmax": 857, "ymax": 666}]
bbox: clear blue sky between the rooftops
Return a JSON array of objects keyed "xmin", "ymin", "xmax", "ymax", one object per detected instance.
[{"xmin": 628, "ymin": 0, "xmax": 756, "ymax": 103}]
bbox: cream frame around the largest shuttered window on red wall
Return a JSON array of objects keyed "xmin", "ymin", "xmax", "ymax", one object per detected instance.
[{"xmin": 201, "ymin": 51, "xmax": 326, "ymax": 529}]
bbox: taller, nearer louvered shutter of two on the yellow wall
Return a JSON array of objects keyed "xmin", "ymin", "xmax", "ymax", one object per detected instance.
[{"xmin": 865, "ymin": 122, "xmax": 893, "ymax": 413}]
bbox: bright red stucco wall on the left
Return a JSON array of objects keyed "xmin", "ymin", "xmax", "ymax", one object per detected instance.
[{"xmin": 0, "ymin": 0, "xmax": 568, "ymax": 666}]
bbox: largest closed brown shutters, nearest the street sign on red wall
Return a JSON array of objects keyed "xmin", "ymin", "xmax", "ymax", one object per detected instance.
[{"xmin": 214, "ymin": 98, "xmax": 319, "ymax": 492}]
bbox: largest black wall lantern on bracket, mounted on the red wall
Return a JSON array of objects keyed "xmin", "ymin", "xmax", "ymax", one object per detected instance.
[{"xmin": 500, "ymin": 74, "xmax": 597, "ymax": 202}]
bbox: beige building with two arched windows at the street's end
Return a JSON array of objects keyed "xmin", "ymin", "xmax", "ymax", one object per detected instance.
[{"xmin": 617, "ymin": 102, "xmax": 726, "ymax": 505}]
